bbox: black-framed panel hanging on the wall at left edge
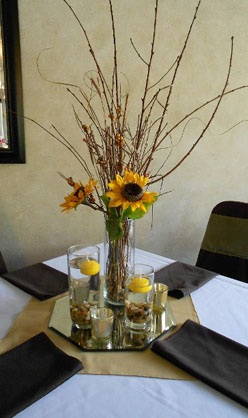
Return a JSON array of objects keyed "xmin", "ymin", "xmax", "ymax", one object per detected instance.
[{"xmin": 0, "ymin": 0, "xmax": 25, "ymax": 164}]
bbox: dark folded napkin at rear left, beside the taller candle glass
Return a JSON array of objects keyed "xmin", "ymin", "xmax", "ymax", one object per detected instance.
[{"xmin": 2, "ymin": 263, "xmax": 68, "ymax": 300}]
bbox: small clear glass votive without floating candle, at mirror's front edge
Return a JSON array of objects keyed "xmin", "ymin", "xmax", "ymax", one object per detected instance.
[{"xmin": 91, "ymin": 308, "xmax": 114, "ymax": 342}]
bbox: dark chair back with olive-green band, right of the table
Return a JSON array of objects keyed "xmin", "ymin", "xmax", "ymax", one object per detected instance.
[{"xmin": 196, "ymin": 201, "xmax": 248, "ymax": 283}]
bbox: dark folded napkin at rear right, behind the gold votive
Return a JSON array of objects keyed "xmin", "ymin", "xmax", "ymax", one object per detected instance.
[{"xmin": 155, "ymin": 261, "xmax": 216, "ymax": 299}]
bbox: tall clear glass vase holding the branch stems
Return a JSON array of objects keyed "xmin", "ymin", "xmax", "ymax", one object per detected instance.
[{"xmin": 104, "ymin": 219, "xmax": 135, "ymax": 306}]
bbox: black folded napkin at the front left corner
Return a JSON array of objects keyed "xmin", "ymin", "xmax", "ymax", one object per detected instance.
[{"xmin": 0, "ymin": 332, "xmax": 83, "ymax": 418}]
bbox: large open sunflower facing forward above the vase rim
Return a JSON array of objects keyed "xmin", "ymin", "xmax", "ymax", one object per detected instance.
[{"xmin": 106, "ymin": 170, "xmax": 157, "ymax": 212}]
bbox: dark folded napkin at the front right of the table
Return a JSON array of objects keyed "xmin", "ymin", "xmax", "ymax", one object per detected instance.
[{"xmin": 152, "ymin": 319, "xmax": 248, "ymax": 407}]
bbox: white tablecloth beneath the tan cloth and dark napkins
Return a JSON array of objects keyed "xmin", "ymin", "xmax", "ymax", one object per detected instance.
[{"xmin": 0, "ymin": 250, "xmax": 248, "ymax": 418}]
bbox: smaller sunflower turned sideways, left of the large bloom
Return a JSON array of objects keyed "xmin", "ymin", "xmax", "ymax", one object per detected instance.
[{"xmin": 60, "ymin": 178, "xmax": 97, "ymax": 213}]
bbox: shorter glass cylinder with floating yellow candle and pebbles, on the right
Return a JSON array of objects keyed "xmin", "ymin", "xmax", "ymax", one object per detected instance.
[{"xmin": 125, "ymin": 264, "xmax": 154, "ymax": 330}]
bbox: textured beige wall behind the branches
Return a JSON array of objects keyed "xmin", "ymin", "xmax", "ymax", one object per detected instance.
[{"xmin": 0, "ymin": 0, "xmax": 248, "ymax": 269}]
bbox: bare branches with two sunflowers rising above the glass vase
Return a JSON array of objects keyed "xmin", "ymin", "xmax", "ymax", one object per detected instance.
[{"xmin": 31, "ymin": 0, "xmax": 248, "ymax": 217}]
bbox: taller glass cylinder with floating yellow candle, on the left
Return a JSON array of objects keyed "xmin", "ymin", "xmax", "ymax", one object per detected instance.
[{"xmin": 67, "ymin": 245, "xmax": 100, "ymax": 328}]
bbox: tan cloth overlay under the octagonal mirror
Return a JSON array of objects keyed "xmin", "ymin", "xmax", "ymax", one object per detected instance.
[{"xmin": 0, "ymin": 294, "xmax": 199, "ymax": 380}]
